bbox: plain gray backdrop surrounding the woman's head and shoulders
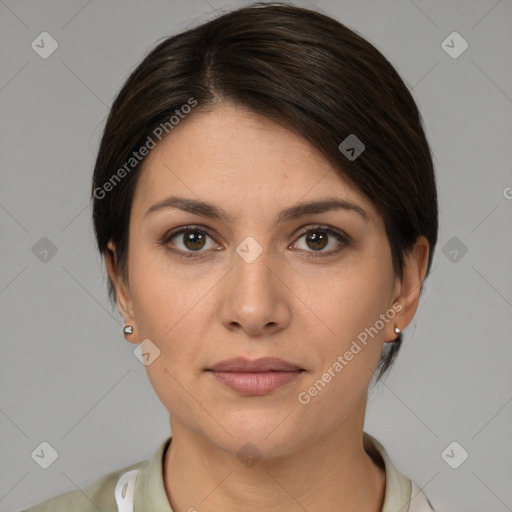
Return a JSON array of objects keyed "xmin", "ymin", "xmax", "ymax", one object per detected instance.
[{"xmin": 0, "ymin": 0, "xmax": 512, "ymax": 512}]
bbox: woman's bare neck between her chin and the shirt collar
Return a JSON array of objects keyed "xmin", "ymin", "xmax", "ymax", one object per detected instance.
[{"xmin": 164, "ymin": 400, "xmax": 385, "ymax": 512}]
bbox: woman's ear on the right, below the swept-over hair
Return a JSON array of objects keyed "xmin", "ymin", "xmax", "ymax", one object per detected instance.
[{"xmin": 386, "ymin": 236, "xmax": 430, "ymax": 341}]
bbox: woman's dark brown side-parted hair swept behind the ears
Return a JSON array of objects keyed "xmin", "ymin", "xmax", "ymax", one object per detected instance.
[{"xmin": 91, "ymin": 2, "xmax": 438, "ymax": 380}]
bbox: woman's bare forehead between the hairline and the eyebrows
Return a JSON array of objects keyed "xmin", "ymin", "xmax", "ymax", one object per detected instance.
[{"xmin": 133, "ymin": 106, "xmax": 376, "ymax": 221}]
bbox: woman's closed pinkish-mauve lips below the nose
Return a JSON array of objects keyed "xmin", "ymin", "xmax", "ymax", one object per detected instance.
[{"xmin": 207, "ymin": 357, "xmax": 305, "ymax": 395}]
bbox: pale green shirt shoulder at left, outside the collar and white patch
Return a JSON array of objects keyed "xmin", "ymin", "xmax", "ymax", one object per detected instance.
[{"xmin": 22, "ymin": 461, "xmax": 148, "ymax": 512}]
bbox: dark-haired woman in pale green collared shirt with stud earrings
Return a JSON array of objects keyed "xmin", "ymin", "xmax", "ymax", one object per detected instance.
[{"xmin": 24, "ymin": 4, "xmax": 438, "ymax": 512}]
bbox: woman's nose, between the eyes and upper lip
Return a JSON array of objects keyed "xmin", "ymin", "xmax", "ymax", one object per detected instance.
[{"xmin": 220, "ymin": 242, "xmax": 291, "ymax": 337}]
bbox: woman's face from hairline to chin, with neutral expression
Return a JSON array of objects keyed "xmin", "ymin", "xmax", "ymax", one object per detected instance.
[{"xmin": 110, "ymin": 106, "xmax": 420, "ymax": 455}]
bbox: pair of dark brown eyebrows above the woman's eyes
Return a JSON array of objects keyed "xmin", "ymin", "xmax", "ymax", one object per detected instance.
[{"xmin": 144, "ymin": 196, "xmax": 370, "ymax": 224}]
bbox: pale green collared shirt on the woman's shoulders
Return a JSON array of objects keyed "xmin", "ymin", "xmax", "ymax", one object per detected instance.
[{"xmin": 23, "ymin": 432, "xmax": 434, "ymax": 512}]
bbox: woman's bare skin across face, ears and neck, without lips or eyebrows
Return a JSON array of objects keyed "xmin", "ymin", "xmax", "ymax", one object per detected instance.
[{"xmin": 107, "ymin": 104, "xmax": 428, "ymax": 512}]
